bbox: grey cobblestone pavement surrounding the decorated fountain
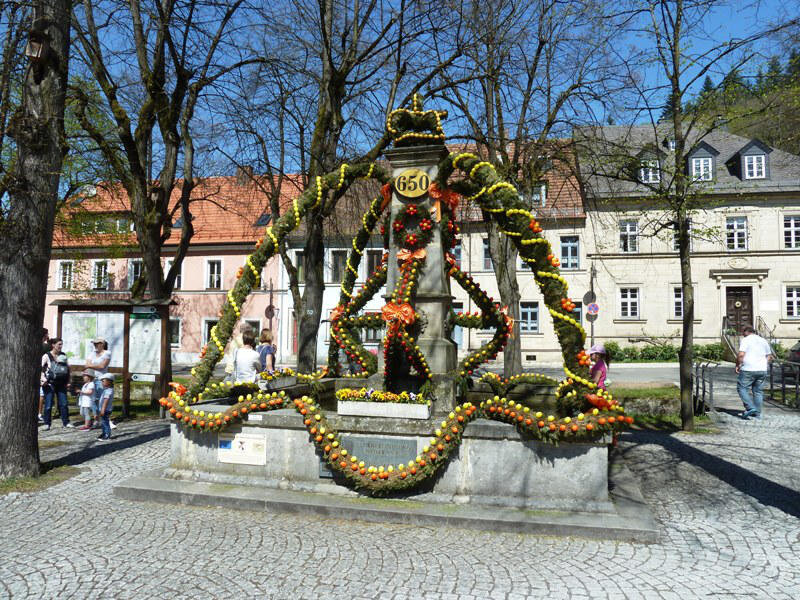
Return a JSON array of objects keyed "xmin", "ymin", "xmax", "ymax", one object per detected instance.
[{"xmin": 0, "ymin": 398, "xmax": 800, "ymax": 600}]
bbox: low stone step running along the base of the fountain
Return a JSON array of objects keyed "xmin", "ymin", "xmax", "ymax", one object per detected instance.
[{"xmin": 114, "ymin": 455, "xmax": 659, "ymax": 543}]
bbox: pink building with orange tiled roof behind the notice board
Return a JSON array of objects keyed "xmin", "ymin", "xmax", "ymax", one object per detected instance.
[{"xmin": 43, "ymin": 178, "xmax": 281, "ymax": 365}]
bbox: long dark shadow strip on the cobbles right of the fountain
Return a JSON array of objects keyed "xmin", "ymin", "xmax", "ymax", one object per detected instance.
[{"xmin": 632, "ymin": 432, "xmax": 800, "ymax": 518}]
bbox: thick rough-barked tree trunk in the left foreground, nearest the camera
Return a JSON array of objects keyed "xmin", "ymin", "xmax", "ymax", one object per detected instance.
[{"xmin": 0, "ymin": 0, "xmax": 71, "ymax": 478}]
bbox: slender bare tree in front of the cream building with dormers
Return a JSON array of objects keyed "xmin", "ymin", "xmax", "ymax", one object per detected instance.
[{"xmin": 582, "ymin": 0, "xmax": 790, "ymax": 431}]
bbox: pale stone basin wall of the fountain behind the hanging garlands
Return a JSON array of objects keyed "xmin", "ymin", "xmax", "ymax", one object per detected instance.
[{"xmin": 165, "ymin": 407, "xmax": 613, "ymax": 513}]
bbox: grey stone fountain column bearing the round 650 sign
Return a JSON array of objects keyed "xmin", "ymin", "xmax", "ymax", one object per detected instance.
[{"xmin": 378, "ymin": 145, "xmax": 458, "ymax": 414}]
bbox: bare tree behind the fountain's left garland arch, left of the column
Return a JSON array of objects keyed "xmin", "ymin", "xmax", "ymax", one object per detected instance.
[{"xmin": 240, "ymin": 0, "xmax": 472, "ymax": 371}]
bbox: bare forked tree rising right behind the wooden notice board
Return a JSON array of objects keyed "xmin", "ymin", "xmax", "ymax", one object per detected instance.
[{"xmin": 71, "ymin": 0, "xmax": 259, "ymax": 299}]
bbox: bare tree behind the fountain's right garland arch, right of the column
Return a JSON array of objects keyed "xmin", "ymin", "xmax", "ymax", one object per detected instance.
[{"xmin": 442, "ymin": 0, "xmax": 625, "ymax": 376}]
